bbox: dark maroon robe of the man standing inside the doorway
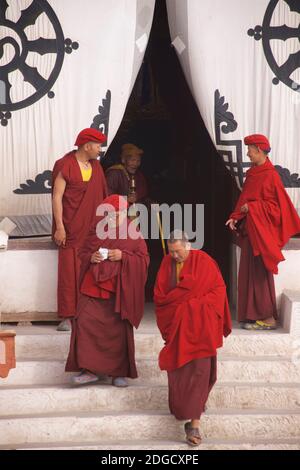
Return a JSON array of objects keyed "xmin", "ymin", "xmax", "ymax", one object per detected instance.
[{"xmin": 105, "ymin": 165, "xmax": 148, "ymax": 202}]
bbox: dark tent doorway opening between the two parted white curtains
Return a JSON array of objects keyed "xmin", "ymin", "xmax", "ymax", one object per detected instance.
[{"xmin": 103, "ymin": 0, "xmax": 237, "ymax": 299}]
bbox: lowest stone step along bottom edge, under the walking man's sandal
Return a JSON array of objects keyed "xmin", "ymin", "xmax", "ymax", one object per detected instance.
[{"xmin": 7, "ymin": 439, "xmax": 300, "ymax": 452}]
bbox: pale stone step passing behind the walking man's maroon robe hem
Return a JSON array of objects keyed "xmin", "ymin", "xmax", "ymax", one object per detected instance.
[{"xmin": 0, "ymin": 383, "xmax": 300, "ymax": 417}]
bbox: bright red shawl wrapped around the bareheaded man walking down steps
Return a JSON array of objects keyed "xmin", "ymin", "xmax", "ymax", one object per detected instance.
[{"xmin": 154, "ymin": 250, "xmax": 231, "ymax": 371}]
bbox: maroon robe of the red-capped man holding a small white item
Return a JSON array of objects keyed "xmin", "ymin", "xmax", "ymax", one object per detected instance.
[{"xmin": 66, "ymin": 221, "xmax": 149, "ymax": 378}]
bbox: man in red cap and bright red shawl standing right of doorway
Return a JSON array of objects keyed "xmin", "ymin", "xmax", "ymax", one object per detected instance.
[{"xmin": 226, "ymin": 134, "xmax": 300, "ymax": 330}]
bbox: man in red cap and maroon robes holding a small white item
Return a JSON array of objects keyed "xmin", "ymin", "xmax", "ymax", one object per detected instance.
[{"xmin": 66, "ymin": 194, "xmax": 149, "ymax": 387}]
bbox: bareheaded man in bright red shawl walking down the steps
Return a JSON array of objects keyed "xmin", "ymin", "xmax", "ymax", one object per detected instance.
[{"xmin": 154, "ymin": 230, "xmax": 231, "ymax": 446}]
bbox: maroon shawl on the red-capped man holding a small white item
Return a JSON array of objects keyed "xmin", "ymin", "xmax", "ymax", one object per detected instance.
[{"xmin": 79, "ymin": 220, "xmax": 149, "ymax": 328}]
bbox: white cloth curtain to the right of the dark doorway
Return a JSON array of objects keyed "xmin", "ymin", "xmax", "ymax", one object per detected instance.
[{"xmin": 167, "ymin": 0, "xmax": 300, "ymax": 212}]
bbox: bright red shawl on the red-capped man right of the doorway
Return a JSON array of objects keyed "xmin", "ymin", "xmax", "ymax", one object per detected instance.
[{"xmin": 230, "ymin": 158, "xmax": 300, "ymax": 274}]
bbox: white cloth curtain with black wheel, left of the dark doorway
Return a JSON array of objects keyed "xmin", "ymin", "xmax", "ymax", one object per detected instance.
[{"xmin": 0, "ymin": 0, "xmax": 155, "ymax": 234}]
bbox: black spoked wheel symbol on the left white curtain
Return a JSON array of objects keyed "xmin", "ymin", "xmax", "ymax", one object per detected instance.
[{"xmin": 0, "ymin": 0, "xmax": 79, "ymax": 126}]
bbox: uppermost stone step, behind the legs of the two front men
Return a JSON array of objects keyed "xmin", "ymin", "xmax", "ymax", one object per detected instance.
[{"xmin": 10, "ymin": 324, "xmax": 299, "ymax": 360}]
